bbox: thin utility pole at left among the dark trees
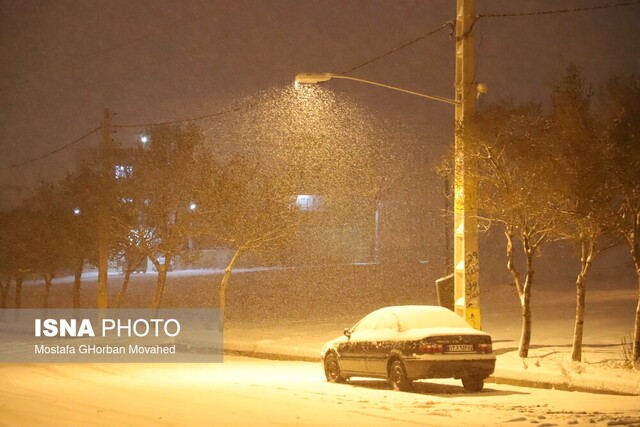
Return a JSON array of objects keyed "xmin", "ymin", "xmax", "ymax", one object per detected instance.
[{"xmin": 98, "ymin": 108, "xmax": 113, "ymax": 309}]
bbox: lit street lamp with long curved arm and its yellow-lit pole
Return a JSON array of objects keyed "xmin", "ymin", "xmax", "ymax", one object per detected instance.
[{"xmin": 295, "ymin": 68, "xmax": 488, "ymax": 329}]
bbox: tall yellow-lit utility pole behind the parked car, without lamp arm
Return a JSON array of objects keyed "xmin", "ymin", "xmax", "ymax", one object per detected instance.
[{"xmin": 453, "ymin": 0, "xmax": 481, "ymax": 329}]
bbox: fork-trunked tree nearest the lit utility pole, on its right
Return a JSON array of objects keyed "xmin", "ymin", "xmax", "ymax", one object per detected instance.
[{"xmin": 470, "ymin": 104, "xmax": 556, "ymax": 357}]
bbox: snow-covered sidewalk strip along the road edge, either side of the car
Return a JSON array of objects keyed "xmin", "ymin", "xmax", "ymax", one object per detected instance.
[{"xmin": 178, "ymin": 323, "xmax": 640, "ymax": 395}]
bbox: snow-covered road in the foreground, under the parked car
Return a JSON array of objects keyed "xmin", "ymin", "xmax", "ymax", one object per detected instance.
[{"xmin": 0, "ymin": 357, "xmax": 640, "ymax": 427}]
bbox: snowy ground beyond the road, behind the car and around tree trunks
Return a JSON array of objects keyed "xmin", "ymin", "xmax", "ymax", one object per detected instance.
[{"xmin": 5, "ymin": 268, "xmax": 640, "ymax": 407}]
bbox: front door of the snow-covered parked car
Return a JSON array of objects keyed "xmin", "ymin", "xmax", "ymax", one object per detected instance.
[{"xmin": 338, "ymin": 312, "xmax": 378, "ymax": 374}]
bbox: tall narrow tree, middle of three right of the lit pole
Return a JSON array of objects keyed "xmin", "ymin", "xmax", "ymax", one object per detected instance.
[{"xmin": 547, "ymin": 65, "xmax": 612, "ymax": 361}]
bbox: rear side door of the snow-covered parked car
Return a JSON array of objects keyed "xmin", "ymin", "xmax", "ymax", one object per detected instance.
[{"xmin": 366, "ymin": 312, "xmax": 398, "ymax": 377}]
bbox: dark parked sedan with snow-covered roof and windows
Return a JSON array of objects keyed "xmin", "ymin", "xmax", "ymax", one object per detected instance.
[{"xmin": 321, "ymin": 305, "xmax": 496, "ymax": 392}]
